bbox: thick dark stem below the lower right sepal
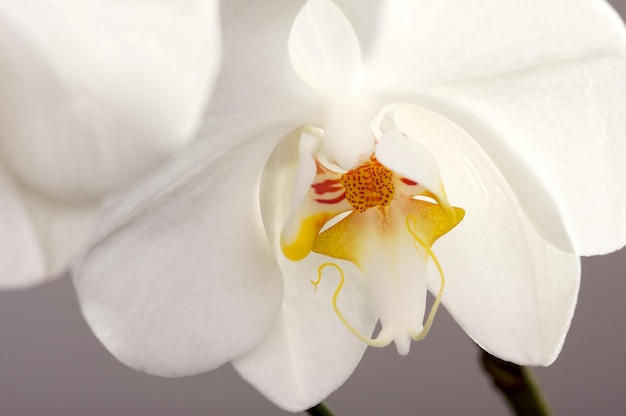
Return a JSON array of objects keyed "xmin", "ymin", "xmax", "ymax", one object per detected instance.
[{"xmin": 481, "ymin": 351, "xmax": 551, "ymax": 416}]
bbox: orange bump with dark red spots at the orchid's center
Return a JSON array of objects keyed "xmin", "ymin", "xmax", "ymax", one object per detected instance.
[{"xmin": 340, "ymin": 156, "xmax": 394, "ymax": 212}]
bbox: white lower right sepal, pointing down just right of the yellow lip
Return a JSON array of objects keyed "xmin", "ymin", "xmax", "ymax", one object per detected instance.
[{"xmin": 388, "ymin": 107, "xmax": 580, "ymax": 365}]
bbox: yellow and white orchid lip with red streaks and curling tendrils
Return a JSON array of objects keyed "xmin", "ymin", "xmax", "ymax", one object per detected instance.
[{"xmin": 281, "ymin": 114, "xmax": 464, "ymax": 355}]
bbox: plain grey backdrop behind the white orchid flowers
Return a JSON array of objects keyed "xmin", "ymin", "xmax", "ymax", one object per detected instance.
[{"xmin": 0, "ymin": 0, "xmax": 626, "ymax": 416}]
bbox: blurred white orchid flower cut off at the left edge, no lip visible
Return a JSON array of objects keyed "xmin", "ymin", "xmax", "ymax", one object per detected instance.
[{"xmin": 0, "ymin": 0, "xmax": 220, "ymax": 288}]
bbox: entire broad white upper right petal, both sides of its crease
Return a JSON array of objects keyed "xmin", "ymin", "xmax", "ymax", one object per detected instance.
[{"xmin": 352, "ymin": 0, "xmax": 626, "ymax": 255}]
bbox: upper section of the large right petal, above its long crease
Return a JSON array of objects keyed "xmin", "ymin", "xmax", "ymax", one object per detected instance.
[{"xmin": 364, "ymin": 0, "xmax": 624, "ymax": 97}]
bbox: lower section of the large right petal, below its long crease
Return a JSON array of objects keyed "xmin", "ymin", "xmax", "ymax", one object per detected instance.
[{"xmin": 414, "ymin": 56, "xmax": 626, "ymax": 255}]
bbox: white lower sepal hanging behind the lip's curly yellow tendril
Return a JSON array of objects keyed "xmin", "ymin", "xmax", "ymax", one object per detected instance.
[{"xmin": 233, "ymin": 135, "xmax": 376, "ymax": 412}]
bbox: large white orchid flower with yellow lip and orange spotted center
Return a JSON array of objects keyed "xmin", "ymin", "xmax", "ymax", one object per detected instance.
[{"xmin": 75, "ymin": 0, "xmax": 626, "ymax": 411}]
